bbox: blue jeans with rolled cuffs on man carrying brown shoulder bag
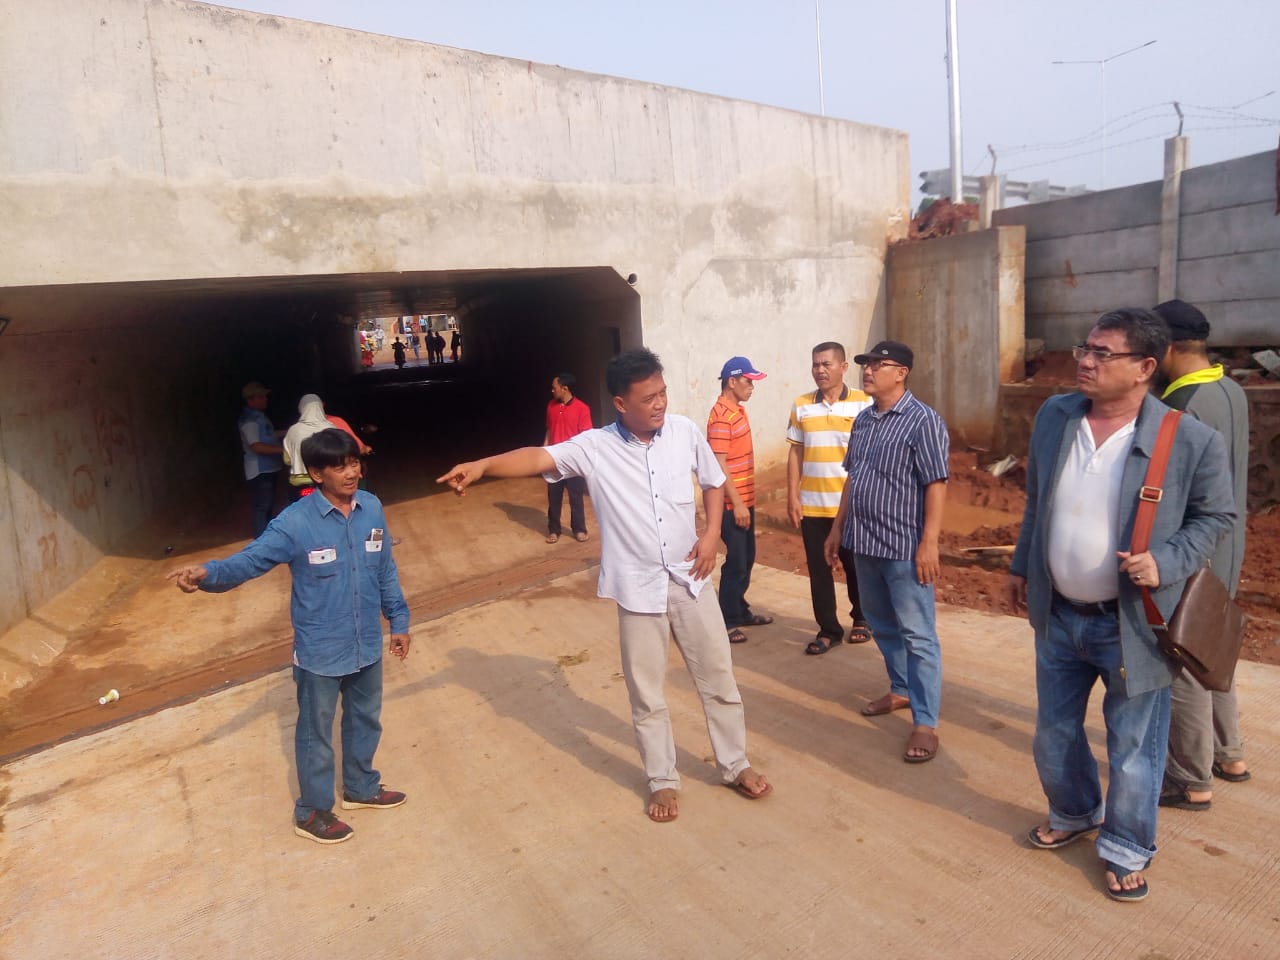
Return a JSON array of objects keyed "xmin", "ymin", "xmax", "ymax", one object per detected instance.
[{"xmin": 1034, "ymin": 596, "xmax": 1169, "ymax": 870}]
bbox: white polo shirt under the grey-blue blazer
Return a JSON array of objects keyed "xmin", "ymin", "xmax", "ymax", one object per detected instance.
[{"xmin": 1048, "ymin": 417, "xmax": 1134, "ymax": 603}]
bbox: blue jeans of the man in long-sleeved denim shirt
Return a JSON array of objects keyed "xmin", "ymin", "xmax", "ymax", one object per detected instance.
[{"xmin": 293, "ymin": 660, "xmax": 383, "ymax": 822}]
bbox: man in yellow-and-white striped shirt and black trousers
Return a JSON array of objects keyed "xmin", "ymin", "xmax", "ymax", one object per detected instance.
[{"xmin": 787, "ymin": 340, "xmax": 872, "ymax": 654}]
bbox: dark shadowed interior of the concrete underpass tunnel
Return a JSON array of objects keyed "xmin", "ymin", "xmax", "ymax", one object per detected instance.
[{"xmin": 0, "ymin": 266, "xmax": 643, "ymax": 552}]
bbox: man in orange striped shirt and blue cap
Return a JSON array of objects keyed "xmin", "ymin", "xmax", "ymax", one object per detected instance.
[{"xmin": 707, "ymin": 357, "xmax": 773, "ymax": 644}]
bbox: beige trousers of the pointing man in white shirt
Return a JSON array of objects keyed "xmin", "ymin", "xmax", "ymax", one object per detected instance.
[{"xmin": 618, "ymin": 580, "xmax": 751, "ymax": 794}]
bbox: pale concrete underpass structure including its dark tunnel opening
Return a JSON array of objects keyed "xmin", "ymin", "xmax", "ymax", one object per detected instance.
[{"xmin": 0, "ymin": 0, "xmax": 910, "ymax": 640}]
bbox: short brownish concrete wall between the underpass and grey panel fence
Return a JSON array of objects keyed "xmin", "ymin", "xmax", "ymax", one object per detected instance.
[{"xmin": 886, "ymin": 227, "xmax": 1027, "ymax": 448}]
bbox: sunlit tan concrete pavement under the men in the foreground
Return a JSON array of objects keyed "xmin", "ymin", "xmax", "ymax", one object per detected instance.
[{"xmin": 0, "ymin": 560, "xmax": 1280, "ymax": 960}]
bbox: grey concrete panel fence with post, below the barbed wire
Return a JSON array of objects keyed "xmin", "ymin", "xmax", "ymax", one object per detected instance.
[{"xmin": 993, "ymin": 140, "xmax": 1280, "ymax": 349}]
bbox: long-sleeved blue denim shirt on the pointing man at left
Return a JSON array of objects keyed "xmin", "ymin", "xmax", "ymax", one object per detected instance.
[{"xmin": 200, "ymin": 490, "xmax": 408, "ymax": 677}]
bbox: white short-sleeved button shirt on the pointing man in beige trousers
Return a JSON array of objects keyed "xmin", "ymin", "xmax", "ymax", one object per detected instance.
[{"xmin": 543, "ymin": 413, "xmax": 724, "ymax": 613}]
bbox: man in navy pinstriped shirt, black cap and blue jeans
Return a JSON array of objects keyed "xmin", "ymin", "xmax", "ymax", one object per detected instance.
[{"xmin": 826, "ymin": 340, "xmax": 950, "ymax": 763}]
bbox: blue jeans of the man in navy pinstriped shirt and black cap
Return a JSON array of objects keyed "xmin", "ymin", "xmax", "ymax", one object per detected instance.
[{"xmin": 854, "ymin": 553, "xmax": 942, "ymax": 727}]
